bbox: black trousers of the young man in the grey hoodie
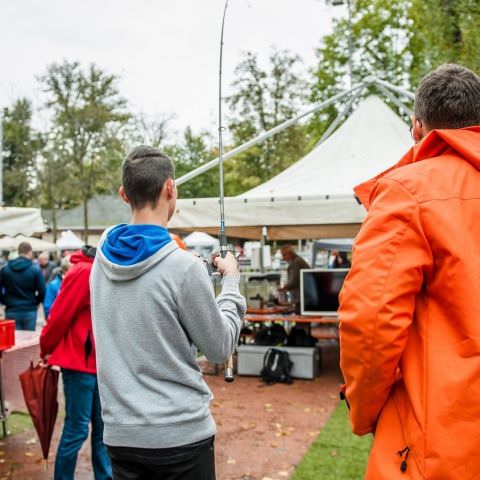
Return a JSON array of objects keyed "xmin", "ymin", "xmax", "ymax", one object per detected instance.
[{"xmin": 107, "ymin": 437, "xmax": 215, "ymax": 480}]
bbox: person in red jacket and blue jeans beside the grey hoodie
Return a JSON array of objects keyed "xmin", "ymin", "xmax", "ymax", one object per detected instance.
[{"xmin": 40, "ymin": 247, "xmax": 112, "ymax": 480}]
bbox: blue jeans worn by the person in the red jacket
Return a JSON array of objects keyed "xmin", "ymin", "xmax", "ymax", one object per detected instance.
[{"xmin": 54, "ymin": 369, "xmax": 112, "ymax": 480}]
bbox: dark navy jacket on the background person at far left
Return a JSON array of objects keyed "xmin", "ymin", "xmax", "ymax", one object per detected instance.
[{"xmin": 0, "ymin": 256, "xmax": 45, "ymax": 312}]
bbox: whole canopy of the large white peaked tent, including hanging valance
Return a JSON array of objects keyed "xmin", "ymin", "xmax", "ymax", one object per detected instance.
[{"xmin": 169, "ymin": 96, "xmax": 412, "ymax": 239}]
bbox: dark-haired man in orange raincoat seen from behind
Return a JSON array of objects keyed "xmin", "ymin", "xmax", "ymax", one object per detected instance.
[{"xmin": 339, "ymin": 64, "xmax": 480, "ymax": 480}]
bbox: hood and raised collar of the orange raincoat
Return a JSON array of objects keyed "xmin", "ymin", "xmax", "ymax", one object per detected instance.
[{"xmin": 354, "ymin": 126, "xmax": 480, "ymax": 210}]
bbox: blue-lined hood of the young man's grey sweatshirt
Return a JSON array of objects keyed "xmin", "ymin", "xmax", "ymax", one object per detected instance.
[{"xmin": 97, "ymin": 224, "xmax": 178, "ymax": 281}]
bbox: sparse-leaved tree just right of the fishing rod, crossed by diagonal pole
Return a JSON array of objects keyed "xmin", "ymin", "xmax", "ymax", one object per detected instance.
[{"xmin": 225, "ymin": 50, "xmax": 308, "ymax": 195}]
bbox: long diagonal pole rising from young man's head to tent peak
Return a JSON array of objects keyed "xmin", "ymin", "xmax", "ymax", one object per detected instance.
[{"xmin": 175, "ymin": 83, "xmax": 365, "ymax": 186}]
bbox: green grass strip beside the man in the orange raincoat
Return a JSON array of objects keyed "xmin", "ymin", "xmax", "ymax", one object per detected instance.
[{"xmin": 292, "ymin": 402, "xmax": 372, "ymax": 480}]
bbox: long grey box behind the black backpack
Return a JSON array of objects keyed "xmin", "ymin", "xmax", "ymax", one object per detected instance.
[{"xmin": 237, "ymin": 345, "xmax": 320, "ymax": 380}]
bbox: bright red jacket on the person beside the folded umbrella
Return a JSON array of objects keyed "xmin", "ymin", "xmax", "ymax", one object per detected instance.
[{"xmin": 40, "ymin": 251, "xmax": 97, "ymax": 373}]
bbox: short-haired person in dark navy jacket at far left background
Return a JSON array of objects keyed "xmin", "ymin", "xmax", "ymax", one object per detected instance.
[{"xmin": 0, "ymin": 242, "xmax": 45, "ymax": 330}]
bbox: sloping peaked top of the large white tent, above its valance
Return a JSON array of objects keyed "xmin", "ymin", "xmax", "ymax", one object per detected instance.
[{"xmin": 241, "ymin": 95, "xmax": 412, "ymax": 198}]
